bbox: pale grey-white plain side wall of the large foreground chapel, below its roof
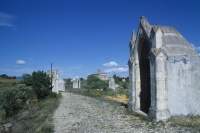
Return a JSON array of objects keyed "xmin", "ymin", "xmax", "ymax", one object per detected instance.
[{"xmin": 167, "ymin": 57, "xmax": 200, "ymax": 115}]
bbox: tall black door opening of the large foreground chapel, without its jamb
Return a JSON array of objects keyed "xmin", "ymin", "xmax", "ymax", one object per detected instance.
[{"xmin": 139, "ymin": 41, "xmax": 151, "ymax": 114}]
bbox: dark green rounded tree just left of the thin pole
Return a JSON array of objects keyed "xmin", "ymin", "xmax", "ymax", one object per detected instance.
[{"xmin": 32, "ymin": 71, "xmax": 52, "ymax": 99}]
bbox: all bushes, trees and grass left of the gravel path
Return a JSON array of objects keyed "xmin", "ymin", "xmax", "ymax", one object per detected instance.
[{"xmin": 0, "ymin": 71, "xmax": 61, "ymax": 132}]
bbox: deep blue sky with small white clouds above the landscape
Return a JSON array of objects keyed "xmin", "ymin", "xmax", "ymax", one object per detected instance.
[{"xmin": 0, "ymin": 0, "xmax": 200, "ymax": 78}]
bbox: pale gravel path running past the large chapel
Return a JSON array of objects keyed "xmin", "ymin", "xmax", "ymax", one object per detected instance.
[{"xmin": 53, "ymin": 92, "xmax": 195, "ymax": 133}]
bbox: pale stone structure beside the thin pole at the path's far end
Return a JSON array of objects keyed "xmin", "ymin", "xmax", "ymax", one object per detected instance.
[{"xmin": 47, "ymin": 69, "xmax": 66, "ymax": 93}]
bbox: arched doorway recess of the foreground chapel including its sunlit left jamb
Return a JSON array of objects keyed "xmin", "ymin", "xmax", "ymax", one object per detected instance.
[{"xmin": 135, "ymin": 37, "xmax": 151, "ymax": 114}]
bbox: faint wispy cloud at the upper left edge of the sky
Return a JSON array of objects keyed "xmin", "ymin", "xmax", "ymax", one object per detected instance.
[{"xmin": 0, "ymin": 12, "xmax": 15, "ymax": 27}]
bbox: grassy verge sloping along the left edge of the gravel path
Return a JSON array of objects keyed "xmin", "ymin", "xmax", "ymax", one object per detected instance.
[{"xmin": 1, "ymin": 95, "xmax": 61, "ymax": 133}]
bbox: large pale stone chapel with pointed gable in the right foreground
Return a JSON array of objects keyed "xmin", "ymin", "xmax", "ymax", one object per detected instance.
[{"xmin": 128, "ymin": 16, "xmax": 200, "ymax": 121}]
